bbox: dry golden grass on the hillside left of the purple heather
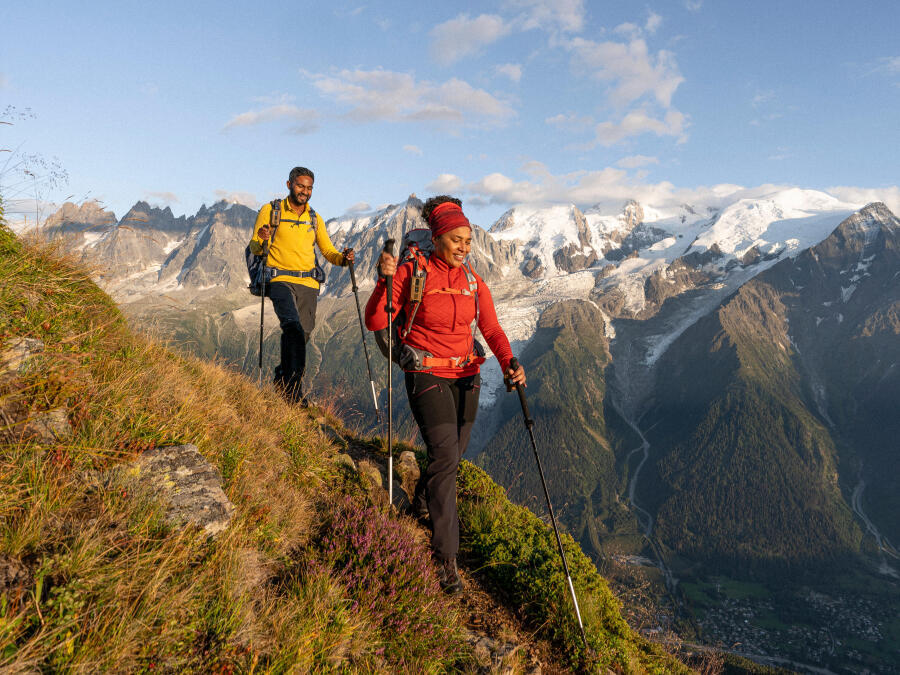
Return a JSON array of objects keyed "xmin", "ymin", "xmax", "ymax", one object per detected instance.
[{"xmin": 0, "ymin": 229, "xmax": 474, "ymax": 672}]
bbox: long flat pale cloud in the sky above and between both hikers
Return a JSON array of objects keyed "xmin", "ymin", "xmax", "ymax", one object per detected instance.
[{"xmin": 307, "ymin": 69, "xmax": 516, "ymax": 123}]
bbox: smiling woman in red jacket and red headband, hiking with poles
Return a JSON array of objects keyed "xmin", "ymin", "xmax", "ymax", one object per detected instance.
[{"xmin": 366, "ymin": 196, "xmax": 525, "ymax": 593}]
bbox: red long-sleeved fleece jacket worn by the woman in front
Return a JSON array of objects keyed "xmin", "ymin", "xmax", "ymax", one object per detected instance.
[{"xmin": 366, "ymin": 255, "xmax": 513, "ymax": 378}]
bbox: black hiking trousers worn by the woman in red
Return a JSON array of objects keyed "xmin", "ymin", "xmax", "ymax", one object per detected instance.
[{"xmin": 406, "ymin": 373, "xmax": 481, "ymax": 561}]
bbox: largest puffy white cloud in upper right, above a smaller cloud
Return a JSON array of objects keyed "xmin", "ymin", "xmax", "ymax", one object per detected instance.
[{"xmin": 569, "ymin": 38, "xmax": 684, "ymax": 108}]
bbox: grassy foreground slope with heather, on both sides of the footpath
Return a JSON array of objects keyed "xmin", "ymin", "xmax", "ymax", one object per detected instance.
[{"xmin": 0, "ymin": 219, "xmax": 685, "ymax": 672}]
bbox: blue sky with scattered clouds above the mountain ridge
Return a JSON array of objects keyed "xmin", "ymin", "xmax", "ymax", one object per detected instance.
[{"xmin": 0, "ymin": 0, "xmax": 900, "ymax": 226}]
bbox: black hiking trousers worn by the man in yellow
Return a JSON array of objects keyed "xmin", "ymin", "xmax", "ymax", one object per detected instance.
[{"xmin": 269, "ymin": 281, "xmax": 319, "ymax": 401}]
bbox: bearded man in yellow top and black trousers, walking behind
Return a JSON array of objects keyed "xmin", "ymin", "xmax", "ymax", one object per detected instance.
[{"xmin": 250, "ymin": 166, "xmax": 353, "ymax": 406}]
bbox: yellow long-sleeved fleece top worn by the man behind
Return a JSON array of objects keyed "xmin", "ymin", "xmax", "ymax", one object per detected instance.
[{"xmin": 250, "ymin": 199, "xmax": 345, "ymax": 288}]
